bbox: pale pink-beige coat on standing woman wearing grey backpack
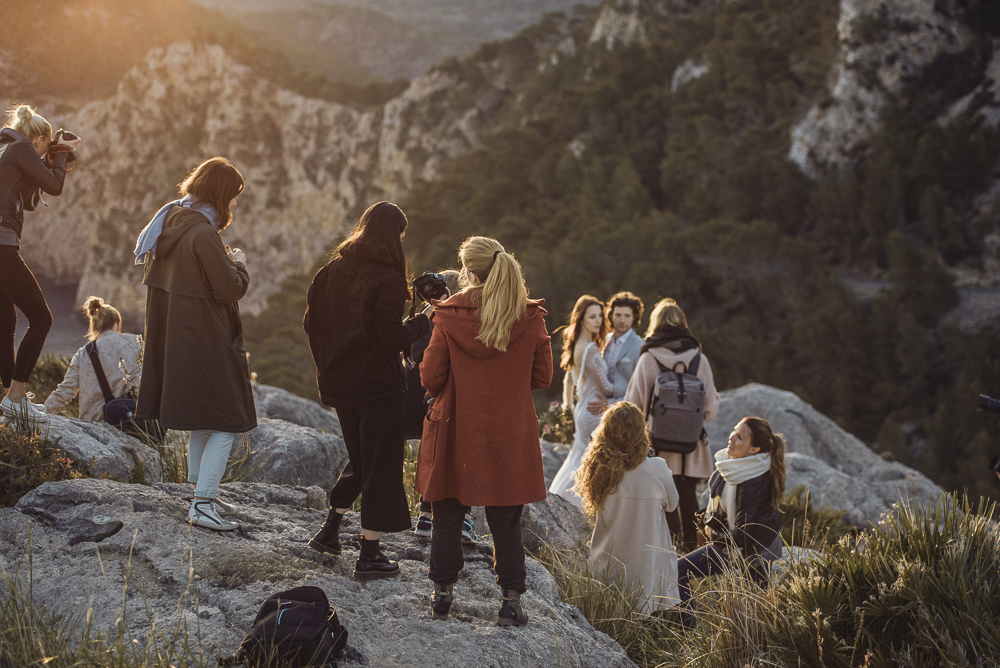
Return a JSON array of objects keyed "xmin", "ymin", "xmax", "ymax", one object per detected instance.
[{"xmin": 625, "ymin": 348, "xmax": 721, "ymax": 480}]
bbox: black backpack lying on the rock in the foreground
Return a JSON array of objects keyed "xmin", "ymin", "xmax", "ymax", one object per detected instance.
[{"xmin": 219, "ymin": 586, "xmax": 347, "ymax": 668}]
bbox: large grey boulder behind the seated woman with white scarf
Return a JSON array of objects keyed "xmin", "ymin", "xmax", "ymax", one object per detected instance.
[{"xmin": 705, "ymin": 383, "xmax": 944, "ymax": 527}]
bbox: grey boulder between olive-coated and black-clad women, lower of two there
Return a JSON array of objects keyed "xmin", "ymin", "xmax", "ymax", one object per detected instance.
[{"xmin": 244, "ymin": 420, "xmax": 348, "ymax": 489}]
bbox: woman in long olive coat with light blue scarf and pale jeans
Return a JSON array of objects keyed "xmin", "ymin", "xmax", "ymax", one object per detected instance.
[{"xmin": 135, "ymin": 158, "xmax": 257, "ymax": 531}]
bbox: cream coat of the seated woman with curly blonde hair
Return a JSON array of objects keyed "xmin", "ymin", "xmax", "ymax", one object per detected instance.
[{"xmin": 590, "ymin": 457, "xmax": 680, "ymax": 615}]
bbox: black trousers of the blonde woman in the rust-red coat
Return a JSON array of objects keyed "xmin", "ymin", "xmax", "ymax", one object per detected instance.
[{"xmin": 430, "ymin": 499, "xmax": 527, "ymax": 592}]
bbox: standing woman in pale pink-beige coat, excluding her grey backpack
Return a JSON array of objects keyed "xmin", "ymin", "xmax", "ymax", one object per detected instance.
[{"xmin": 625, "ymin": 299, "xmax": 720, "ymax": 552}]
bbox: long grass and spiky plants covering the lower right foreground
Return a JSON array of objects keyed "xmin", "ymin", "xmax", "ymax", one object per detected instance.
[{"xmin": 542, "ymin": 496, "xmax": 1000, "ymax": 668}]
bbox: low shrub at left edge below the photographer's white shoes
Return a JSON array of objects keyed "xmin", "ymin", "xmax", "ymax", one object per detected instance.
[{"xmin": 0, "ymin": 422, "xmax": 84, "ymax": 508}]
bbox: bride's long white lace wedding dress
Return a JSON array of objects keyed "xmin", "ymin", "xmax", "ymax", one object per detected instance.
[{"xmin": 549, "ymin": 343, "xmax": 615, "ymax": 508}]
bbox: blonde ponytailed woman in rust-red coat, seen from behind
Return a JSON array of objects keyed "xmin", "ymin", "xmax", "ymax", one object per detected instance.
[{"xmin": 416, "ymin": 237, "xmax": 552, "ymax": 626}]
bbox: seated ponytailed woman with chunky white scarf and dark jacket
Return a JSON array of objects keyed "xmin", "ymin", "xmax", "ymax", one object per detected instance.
[{"xmin": 677, "ymin": 417, "xmax": 785, "ymax": 628}]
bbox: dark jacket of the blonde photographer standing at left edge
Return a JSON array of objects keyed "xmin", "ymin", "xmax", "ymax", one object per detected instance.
[{"xmin": 0, "ymin": 128, "xmax": 67, "ymax": 239}]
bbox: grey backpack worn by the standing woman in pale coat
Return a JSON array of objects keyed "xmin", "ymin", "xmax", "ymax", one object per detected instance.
[{"xmin": 646, "ymin": 351, "xmax": 706, "ymax": 455}]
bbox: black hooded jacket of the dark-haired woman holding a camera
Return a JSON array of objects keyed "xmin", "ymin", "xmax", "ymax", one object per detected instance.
[{"xmin": 302, "ymin": 244, "xmax": 430, "ymax": 408}]
